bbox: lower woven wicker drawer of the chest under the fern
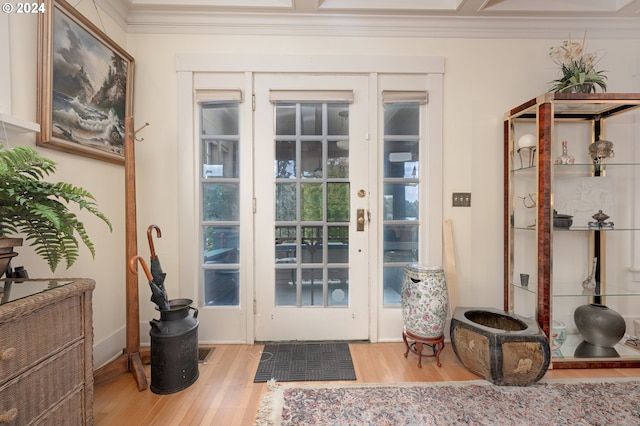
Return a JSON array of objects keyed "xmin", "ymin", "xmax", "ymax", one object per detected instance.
[{"xmin": 0, "ymin": 340, "xmax": 84, "ymax": 425}]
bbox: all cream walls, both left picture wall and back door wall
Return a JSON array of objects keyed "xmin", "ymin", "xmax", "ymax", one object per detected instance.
[{"xmin": 10, "ymin": 3, "xmax": 640, "ymax": 365}]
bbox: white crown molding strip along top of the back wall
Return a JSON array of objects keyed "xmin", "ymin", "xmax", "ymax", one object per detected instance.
[{"xmin": 127, "ymin": 11, "xmax": 640, "ymax": 39}]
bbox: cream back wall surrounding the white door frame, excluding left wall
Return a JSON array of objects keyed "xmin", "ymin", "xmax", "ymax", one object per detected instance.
[{"xmin": 129, "ymin": 34, "xmax": 638, "ymax": 307}]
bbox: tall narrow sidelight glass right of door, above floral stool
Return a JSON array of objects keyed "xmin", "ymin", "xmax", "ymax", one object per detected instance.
[{"xmin": 382, "ymin": 102, "xmax": 425, "ymax": 307}]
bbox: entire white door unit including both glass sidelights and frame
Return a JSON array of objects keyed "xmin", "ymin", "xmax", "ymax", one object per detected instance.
[{"xmin": 176, "ymin": 55, "xmax": 444, "ymax": 343}]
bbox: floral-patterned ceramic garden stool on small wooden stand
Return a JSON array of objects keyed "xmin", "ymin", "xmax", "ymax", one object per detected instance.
[{"xmin": 402, "ymin": 263, "xmax": 449, "ymax": 338}]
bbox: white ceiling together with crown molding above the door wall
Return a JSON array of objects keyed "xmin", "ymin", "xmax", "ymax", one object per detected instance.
[{"xmin": 101, "ymin": 0, "xmax": 640, "ymax": 39}]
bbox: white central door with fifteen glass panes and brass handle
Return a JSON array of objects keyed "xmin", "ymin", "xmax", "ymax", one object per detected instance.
[{"xmin": 254, "ymin": 74, "xmax": 375, "ymax": 341}]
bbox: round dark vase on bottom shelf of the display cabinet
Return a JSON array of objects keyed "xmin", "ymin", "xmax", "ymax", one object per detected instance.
[{"xmin": 573, "ymin": 303, "xmax": 627, "ymax": 348}]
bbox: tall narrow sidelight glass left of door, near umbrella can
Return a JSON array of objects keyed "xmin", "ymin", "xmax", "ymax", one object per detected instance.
[{"xmin": 199, "ymin": 102, "xmax": 240, "ymax": 306}]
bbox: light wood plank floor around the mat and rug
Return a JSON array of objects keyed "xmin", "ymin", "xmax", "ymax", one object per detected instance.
[{"xmin": 94, "ymin": 343, "xmax": 640, "ymax": 426}]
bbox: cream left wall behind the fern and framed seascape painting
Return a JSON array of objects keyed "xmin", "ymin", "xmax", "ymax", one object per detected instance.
[{"xmin": 9, "ymin": 2, "xmax": 126, "ymax": 365}]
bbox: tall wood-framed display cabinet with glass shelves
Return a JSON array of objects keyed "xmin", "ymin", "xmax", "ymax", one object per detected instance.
[{"xmin": 503, "ymin": 93, "xmax": 640, "ymax": 368}]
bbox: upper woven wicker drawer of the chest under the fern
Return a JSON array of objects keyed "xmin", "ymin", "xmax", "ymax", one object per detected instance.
[{"xmin": 0, "ymin": 295, "xmax": 84, "ymax": 383}]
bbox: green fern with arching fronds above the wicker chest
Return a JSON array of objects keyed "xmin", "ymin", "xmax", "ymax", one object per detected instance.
[{"xmin": 0, "ymin": 145, "xmax": 112, "ymax": 276}]
